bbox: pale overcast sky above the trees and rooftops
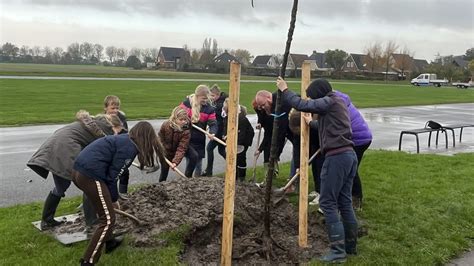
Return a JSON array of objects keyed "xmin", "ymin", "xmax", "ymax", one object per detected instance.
[{"xmin": 0, "ymin": 0, "xmax": 474, "ymax": 61}]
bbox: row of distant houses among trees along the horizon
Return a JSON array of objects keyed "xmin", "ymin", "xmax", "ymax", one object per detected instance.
[{"xmin": 156, "ymin": 47, "xmax": 468, "ymax": 77}]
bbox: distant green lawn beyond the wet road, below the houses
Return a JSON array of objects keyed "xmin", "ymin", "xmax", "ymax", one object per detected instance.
[{"xmin": 0, "ymin": 79, "xmax": 474, "ymax": 126}]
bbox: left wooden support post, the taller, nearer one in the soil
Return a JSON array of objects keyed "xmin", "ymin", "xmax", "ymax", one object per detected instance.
[{"xmin": 221, "ymin": 62, "xmax": 240, "ymax": 266}]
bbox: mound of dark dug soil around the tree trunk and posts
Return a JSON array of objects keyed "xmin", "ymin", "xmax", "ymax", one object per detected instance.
[{"xmin": 119, "ymin": 177, "xmax": 327, "ymax": 265}]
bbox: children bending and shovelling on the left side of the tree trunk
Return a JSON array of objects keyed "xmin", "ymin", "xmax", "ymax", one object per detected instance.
[{"xmin": 27, "ymin": 85, "xmax": 254, "ymax": 265}]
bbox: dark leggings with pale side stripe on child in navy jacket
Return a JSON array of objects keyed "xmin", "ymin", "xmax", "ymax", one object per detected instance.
[{"xmin": 72, "ymin": 171, "xmax": 115, "ymax": 263}]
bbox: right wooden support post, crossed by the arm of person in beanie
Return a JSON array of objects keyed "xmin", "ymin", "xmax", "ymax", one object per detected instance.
[{"xmin": 298, "ymin": 62, "xmax": 311, "ymax": 248}]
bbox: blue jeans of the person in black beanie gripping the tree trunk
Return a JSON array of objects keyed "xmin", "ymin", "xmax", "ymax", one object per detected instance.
[{"xmin": 319, "ymin": 151, "xmax": 357, "ymax": 224}]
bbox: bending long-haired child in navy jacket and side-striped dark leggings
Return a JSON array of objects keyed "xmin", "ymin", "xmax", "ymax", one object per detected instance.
[{"xmin": 72, "ymin": 122, "xmax": 163, "ymax": 265}]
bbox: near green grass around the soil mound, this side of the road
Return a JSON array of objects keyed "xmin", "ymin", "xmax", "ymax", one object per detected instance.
[{"xmin": 0, "ymin": 151, "xmax": 474, "ymax": 265}]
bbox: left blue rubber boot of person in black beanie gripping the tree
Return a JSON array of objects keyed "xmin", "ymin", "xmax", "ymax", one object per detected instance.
[{"xmin": 319, "ymin": 222, "xmax": 346, "ymax": 263}]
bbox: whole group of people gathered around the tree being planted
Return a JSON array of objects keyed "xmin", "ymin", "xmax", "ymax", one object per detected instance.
[{"xmin": 27, "ymin": 78, "xmax": 372, "ymax": 265}]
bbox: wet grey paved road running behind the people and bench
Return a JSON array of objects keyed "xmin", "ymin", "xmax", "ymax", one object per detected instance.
[{"xmin": 0, "ymin": 103, "xmax": 474, "ymax": 207}]
